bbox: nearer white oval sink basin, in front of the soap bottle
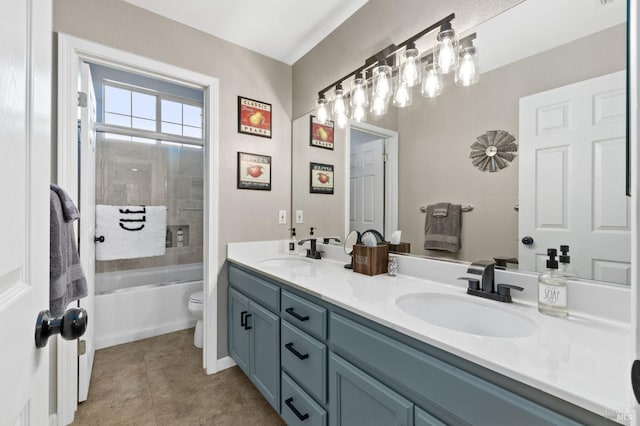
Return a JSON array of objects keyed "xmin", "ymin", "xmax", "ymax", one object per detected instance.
[{"xmin": 396, "ymin": 293, "xmax": 537, "ymax": 338}]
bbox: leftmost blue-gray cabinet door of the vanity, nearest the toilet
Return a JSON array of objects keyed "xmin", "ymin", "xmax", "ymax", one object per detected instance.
[{"xmin": 227, "ymin": 288, "xmax": 250, "ymax": 376}]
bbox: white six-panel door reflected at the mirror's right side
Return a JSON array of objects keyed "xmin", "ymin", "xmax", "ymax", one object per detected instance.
[{"xmin": 519, "ymin": 72, "xmax": 631, "ymax": 284}]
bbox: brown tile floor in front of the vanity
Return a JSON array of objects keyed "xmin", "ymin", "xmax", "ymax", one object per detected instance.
[{"xmin": 73, "ymin": 329, "xmax": 284, "ymax": 426}]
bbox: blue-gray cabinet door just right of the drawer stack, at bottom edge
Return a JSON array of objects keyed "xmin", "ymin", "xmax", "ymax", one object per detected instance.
[{"xmin": 329, "ymin": 353, "xmax": 413, "ymax": 426}]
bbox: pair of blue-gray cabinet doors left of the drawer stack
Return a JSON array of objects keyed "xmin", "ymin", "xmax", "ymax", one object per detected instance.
[{"xmin": 227, "ymin": 288, "xmax": 280, "ymax": 412}]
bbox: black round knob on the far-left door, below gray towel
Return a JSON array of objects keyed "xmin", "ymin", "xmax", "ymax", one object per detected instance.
[{"xmin": 36, "ymin": 308, "xmax": 87, "ymax": 348}]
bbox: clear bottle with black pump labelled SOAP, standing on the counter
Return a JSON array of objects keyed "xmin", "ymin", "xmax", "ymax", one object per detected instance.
[{"xmin": 538, "ymin": 249, "xmax": 569, "ymax": 318}]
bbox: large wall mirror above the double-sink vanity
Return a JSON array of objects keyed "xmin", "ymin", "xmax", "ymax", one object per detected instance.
[{"xmin": 291, "ymin": 0, "xmax": 631, "ymax": 284}]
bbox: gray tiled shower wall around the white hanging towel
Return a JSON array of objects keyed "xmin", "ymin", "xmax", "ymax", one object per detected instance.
[{"xmin": 96, "ymin": 140, "xmax": 204, "ymax": 272}]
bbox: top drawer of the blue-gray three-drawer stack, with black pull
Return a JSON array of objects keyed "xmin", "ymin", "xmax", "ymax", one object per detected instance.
[{"xmin": 280, "ymin": 290, "xmax": 327, "ymax": 340}]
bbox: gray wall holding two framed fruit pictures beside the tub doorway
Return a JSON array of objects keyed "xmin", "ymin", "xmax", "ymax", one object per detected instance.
[{"xmin": 53, "ymin": 0, "xmax": 292, "ymax": 358}]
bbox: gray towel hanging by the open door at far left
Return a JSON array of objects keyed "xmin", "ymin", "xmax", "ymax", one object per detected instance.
[{"xmin": 49, "ymin": 184, "xmax": 87, "ymax": 317}]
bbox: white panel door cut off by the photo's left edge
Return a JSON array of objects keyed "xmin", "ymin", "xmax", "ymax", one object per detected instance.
[{"xmin": 0, "ymin": 0, "xmax": 55, "ymax": 426}]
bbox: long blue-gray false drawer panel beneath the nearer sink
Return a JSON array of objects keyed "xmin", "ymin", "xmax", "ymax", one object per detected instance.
[{"xmin": 329, "ymin": 313, "xmax": 579, "ymax": 426}]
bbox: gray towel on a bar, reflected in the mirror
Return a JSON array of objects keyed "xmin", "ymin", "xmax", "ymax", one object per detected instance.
[{"xmin": 424, "ymin": 204, "xmax": 462, "ymax": 253}]
